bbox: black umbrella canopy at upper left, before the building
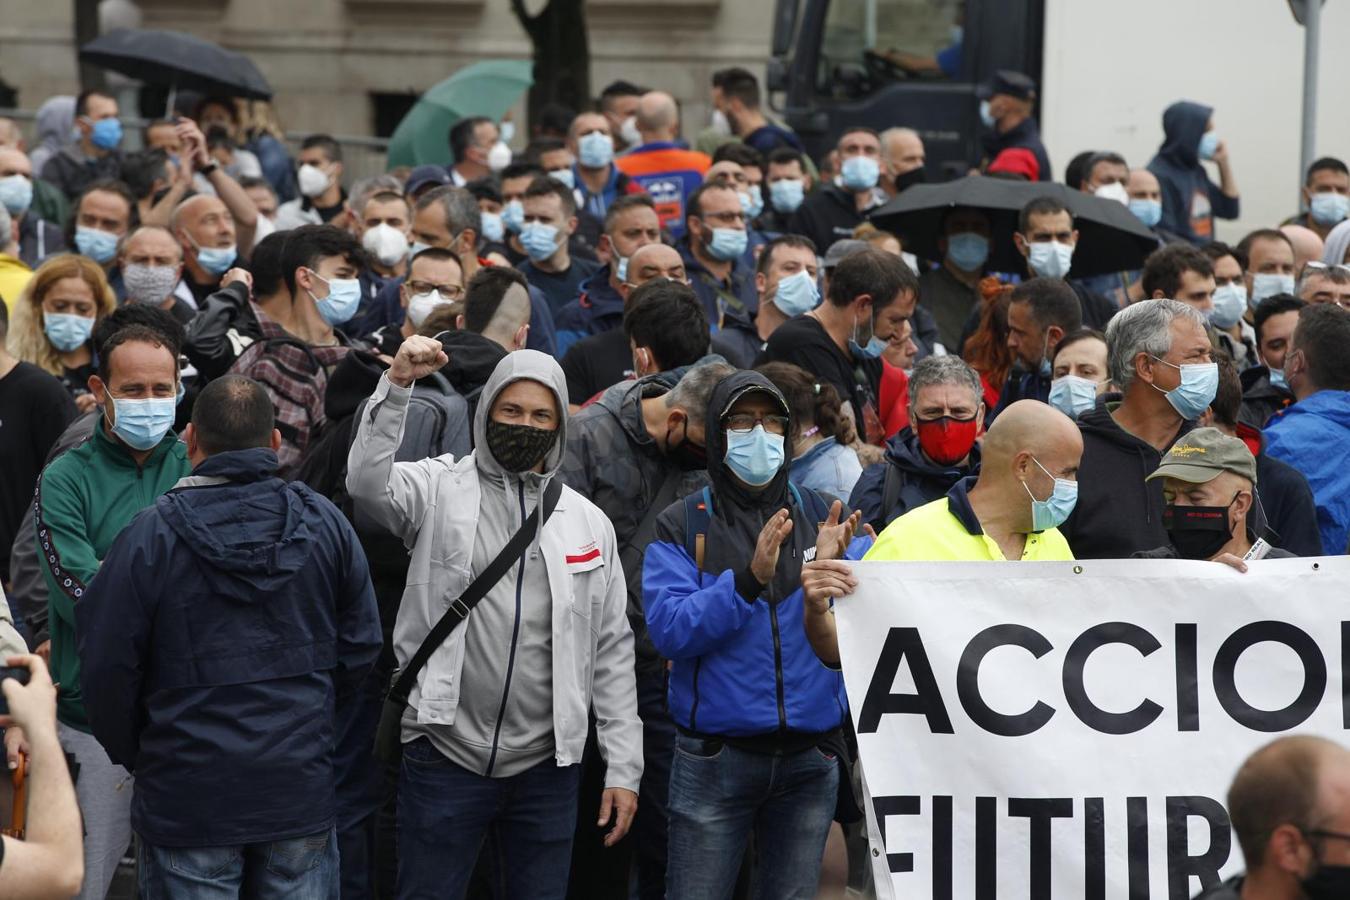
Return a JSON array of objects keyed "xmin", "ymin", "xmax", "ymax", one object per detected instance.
[{"xmin": 80, "ymin": 28, "xmax": 271, "ymax": 100}]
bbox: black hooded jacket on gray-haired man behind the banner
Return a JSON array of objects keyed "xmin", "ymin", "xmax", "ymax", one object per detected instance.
[{"xmin": 1060, "ymin": 394, "xmax": 1195, "ymax": 560}]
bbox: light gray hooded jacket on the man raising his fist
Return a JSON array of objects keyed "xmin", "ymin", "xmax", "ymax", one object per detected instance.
[{"xmin": 347, "ymin": 351, "xmax": 643, "ymax": 791}]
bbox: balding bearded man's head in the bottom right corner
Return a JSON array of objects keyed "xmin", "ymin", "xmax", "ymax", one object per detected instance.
[{"xmin": 1196, "ymin": 735, "xmax": 1350, "ymax": 900}]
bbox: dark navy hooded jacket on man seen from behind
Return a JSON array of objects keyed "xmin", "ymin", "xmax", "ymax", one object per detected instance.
[{"xmin": 76, "ymin": 449, "xmax": 381, "ymax": 847}]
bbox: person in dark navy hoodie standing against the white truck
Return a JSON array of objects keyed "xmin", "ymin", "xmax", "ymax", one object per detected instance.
[{"xmin": 1149, "ymin": 100, "xmax": 1241, "ymax": 244}]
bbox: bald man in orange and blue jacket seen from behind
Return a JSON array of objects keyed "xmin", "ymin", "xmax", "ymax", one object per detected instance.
[{"xmin": 614, "ymin": 90, "xmax": 713, "ymax": 237}]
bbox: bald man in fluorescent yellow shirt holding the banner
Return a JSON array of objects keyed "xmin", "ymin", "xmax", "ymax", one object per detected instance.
[{"xmin": 802, "ymin": 399, "xmax": 1083, "ymax": 665}]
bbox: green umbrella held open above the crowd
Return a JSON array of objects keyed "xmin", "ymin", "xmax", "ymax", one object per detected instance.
[{"xmin": 389, "ymin": 59, "xmax": 535, "ymax": 167}]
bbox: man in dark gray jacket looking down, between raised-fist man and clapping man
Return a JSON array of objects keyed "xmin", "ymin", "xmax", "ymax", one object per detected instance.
[{"xmin": 559, "ymin": 362, "xmax": 736, "ymax": 897}]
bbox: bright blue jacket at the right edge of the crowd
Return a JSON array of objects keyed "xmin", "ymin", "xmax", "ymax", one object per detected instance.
[{"xmin": 1258, "ymin": 390, "xmax": 1350, "ymax": 556}]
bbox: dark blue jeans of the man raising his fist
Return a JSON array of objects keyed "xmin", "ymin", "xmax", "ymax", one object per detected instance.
[{"xmin": 398, "ymin": 738, "xmax": 581, "ymax": 900}]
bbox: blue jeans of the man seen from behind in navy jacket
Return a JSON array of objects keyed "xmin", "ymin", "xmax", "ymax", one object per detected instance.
[{"xmin": 138, "ymin": 830, "xmax": 338, "ymax": 900}]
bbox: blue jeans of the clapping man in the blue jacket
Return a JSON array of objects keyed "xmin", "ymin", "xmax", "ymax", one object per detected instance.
[{"xmin": 666, "ymin": 734, "xmax": 838, "ymax": 900}]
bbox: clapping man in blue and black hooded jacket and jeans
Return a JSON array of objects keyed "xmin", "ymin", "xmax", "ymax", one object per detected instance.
[{"xmin": 643, "ymin": 371, "xmax": 859, "ymax": 900}]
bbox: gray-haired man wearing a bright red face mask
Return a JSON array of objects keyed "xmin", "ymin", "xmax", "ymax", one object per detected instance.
[{"xmin": 848, "ymin": 356, "xmax": 986, "ymax": 534}]
